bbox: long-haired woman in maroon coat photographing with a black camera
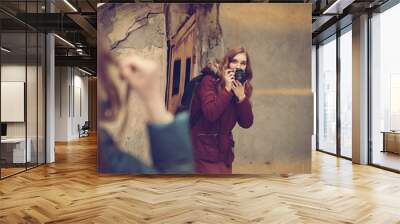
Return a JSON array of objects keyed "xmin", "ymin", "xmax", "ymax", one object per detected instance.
[{"xmin": 191, "ymin": 47, "xmax": 253, "ymax": 174}]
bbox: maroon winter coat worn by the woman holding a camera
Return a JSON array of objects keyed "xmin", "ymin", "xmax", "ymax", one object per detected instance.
[{"xmin": 191, "ymin": 69, "xmax": 253, "ymax": 173}]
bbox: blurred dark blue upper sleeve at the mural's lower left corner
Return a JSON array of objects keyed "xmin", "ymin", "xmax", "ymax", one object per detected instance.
[{"xmin": 97, "ymin": 129, "xmax": 157, "ymax": 174}]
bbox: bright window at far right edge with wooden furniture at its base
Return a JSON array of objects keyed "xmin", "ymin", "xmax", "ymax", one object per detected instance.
[{"xmin": 369, "ymin": 4, "xmax": 400, "ymax": 172}]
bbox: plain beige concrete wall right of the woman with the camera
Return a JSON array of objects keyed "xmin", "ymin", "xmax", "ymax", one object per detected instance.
[{"xmin": 219, "ymin": 3, "xmax": 313, "ymax": 173}]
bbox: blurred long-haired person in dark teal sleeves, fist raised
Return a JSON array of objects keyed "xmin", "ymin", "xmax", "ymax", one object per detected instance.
[{"xmin": 97, "ymin": 35, "xmax": 193, "ymax": 174}]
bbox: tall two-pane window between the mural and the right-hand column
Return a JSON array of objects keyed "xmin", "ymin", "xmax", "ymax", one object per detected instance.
[{"xmin": 316, "ymin": 25, "xmax": 352, "ymax": 159}]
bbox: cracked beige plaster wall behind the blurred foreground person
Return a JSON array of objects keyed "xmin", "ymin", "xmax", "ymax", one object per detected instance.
[{"xmin": 98, "ymin": 4, "xmax": 167, "ymax": 164}]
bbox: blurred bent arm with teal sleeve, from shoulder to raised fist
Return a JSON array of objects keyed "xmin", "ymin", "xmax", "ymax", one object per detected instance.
[{"xmin": 101, "ymin": 50, "xmax": 193, "ymax": 173}]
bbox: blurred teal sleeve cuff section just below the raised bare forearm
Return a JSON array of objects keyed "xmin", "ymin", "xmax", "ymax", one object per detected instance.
[{"xmin": 147, "ymin": 113, "xmax": 193, "ymax": 173}]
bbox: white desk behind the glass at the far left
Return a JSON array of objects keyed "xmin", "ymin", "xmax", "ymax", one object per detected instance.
[{"xmin": 1, "ymin": 138, "xmax": 32, "ymax": 163}]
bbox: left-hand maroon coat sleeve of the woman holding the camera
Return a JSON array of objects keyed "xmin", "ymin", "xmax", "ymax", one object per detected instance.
[{"xmin": 198, "ymin": 76, "xmax": 233, "ymax": 121}]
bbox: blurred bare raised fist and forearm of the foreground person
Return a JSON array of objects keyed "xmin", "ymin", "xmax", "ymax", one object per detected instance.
[{"xmin": 118, "ymin": 55, "xmax": 173, "ymax": 123}]
